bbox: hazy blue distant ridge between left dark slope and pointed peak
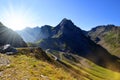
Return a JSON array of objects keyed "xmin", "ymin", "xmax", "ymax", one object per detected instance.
[{"xmin": 16, "ymin": 25, "xmax": 52, "ymax": 42}]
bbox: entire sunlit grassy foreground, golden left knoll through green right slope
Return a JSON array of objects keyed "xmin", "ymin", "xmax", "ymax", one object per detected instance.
[{"xmin": 0, "ymin": 48, "xmax": 120, "ymax": 80}]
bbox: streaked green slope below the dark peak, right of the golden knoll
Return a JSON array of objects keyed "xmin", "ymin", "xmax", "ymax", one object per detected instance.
[{"xmin": 50, "ymin": 50, "xmax": 120, "ymax": 80}]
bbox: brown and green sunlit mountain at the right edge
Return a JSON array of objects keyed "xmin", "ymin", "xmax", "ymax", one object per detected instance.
[{"xmin": 87, "ymin": 25, "xmax": 120, "ymax": 57}]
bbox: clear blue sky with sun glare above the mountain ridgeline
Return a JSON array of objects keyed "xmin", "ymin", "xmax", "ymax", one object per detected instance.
[{"xmin": 0, "ymin": 0, "xmax": 120, "ymax": 30}]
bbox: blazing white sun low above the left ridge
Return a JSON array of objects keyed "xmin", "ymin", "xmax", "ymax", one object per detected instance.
[{"xmin": 4, "ymin": 14, "xmax": 27, "ymax": 30}]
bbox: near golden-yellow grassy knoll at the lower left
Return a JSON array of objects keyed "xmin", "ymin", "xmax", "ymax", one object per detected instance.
[{"xmin": 0, "ymin": 49, "xmax": 76, "ymax": 80}]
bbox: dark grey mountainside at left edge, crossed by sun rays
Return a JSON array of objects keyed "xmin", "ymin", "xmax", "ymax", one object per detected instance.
[{"xmin": 0, "ymin": 23, "xmax": 27, "ymax": 47}]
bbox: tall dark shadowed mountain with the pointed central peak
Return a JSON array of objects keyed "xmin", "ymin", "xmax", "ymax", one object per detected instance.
[{"xmin": 17, "ymin": 18, "xmax": 120, "ymax": 71}]
